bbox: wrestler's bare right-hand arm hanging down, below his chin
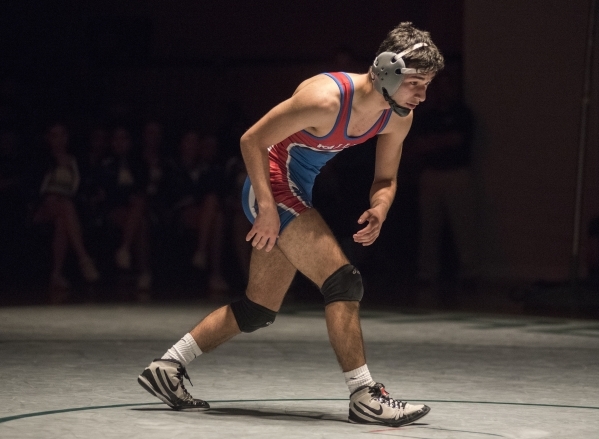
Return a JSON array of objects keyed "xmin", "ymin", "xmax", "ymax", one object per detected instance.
[{"xmin": 353, "ymin": 114, "xmax": 412, "ymax": 245}]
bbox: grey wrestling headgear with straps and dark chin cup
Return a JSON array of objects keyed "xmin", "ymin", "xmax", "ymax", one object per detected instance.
[{"xmin": 370, "ymin": 43, "xmax": 428, "ymax": 117}]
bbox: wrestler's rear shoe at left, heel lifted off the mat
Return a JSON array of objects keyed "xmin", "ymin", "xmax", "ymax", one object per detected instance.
[{"xmin": 137, "ymin": 358, "xmax": 210, "ymax": 412}]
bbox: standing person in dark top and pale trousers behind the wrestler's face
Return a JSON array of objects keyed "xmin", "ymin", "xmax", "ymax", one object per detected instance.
[{"xmin": 412, "ymin": 61, "xmax": 478, "ymax": 306}]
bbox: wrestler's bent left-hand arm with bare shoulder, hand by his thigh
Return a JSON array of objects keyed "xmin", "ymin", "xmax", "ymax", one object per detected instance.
[{"xmin": 241, "ymin": 75, "xmax": 340, "ymax": 251}]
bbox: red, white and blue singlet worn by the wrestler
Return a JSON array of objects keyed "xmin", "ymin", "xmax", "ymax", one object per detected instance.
[{"xmin": 242, "ymin": 72, "xmax": 392, "ymax": 231}]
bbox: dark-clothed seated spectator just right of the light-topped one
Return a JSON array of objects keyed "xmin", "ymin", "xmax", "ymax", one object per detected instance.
[{"xmin": 98, "ymin": 126, "xmax": 152, "ymax": 300}]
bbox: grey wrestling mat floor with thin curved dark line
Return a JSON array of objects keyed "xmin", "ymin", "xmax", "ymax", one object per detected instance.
[{"xmin": 0, "ymin": 304, "xmax": 599, "ymax": 439}]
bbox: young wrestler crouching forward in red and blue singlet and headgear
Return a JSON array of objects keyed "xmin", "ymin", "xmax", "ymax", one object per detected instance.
[{"xmin": 138, "ymin": 23, "xmax": 443, "ymax": 426}]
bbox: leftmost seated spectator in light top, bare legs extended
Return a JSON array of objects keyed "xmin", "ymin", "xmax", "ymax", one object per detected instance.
[{"xmin": 33, "ymin": 123, "xmax": 99, "ymax": 301}]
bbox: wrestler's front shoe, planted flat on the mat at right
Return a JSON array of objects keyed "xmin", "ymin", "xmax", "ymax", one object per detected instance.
[{"xmin": 348, "ymin": 383, "xmax": 431, "ymax": 427}]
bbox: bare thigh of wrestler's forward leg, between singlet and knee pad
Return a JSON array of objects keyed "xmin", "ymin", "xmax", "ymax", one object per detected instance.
[{"xmin": 277, "ymin": 209, "xmax": 349, "ymax": 288}]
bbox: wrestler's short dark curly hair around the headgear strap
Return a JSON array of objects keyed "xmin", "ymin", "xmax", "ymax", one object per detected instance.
[{"xmin": 376, "ymin": 21, "xmax": 445, "ymax": 73}]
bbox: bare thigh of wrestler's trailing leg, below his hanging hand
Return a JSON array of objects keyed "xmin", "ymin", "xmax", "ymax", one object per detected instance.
[{"xmin": 246, "ymin": 245, "xmax": 297, "ymax": 311}]
